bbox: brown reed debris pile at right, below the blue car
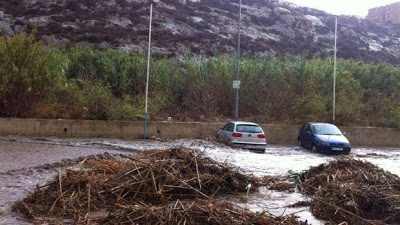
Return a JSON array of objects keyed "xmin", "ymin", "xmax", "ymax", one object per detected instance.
[{"xmin": 300, "ymin": 158, "xmax": 400, "ymax": 224}]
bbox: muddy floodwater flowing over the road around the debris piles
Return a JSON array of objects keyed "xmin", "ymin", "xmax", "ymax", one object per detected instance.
[{"xmin": 0, "ymin": 137, "xmax": 400, "ymax": 224}]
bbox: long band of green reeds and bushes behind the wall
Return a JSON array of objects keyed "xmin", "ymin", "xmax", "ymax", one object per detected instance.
[{"xmin": 0, "ymin": 36, "xmax": 400, "ymax": 127}]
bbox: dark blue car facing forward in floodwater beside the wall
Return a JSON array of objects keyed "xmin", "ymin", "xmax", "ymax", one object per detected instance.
[{"xmin": 297, "ymin": 122, "xmax": 351, "ymax": 154}]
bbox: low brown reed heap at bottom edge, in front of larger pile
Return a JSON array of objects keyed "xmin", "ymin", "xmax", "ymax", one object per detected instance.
[{"xmin": 100, "ymin": 200, "xmax": 307, "ymax": 225}]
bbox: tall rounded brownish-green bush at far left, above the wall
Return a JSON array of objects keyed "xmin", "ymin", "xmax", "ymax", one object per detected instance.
[{"xmin": 0, "ymin": 35, "xmax": 67, "ymax": 117}]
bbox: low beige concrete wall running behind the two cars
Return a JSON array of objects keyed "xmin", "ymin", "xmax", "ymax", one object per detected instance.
[{"xmin": 0, "ymin": 118, "xmax": 400, "ymax": 147}]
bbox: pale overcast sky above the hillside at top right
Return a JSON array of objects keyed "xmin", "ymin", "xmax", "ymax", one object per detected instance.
[{"xmin": 286, "ymin": 0, "xmax": 400, "ymax": 17}]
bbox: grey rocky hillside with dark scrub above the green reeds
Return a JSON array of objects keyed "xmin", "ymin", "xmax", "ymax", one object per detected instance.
[{"xmin": 0, "ymin": 0, "xmax": 400, "ymax": 66}]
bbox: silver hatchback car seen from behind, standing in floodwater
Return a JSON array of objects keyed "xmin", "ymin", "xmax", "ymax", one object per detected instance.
[{"xmin": 217, "ymin": 121, "xmax": 267, "ymax": 151}]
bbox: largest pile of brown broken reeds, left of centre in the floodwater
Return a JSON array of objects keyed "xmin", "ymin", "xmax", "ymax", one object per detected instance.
[{"xmin": 13, "ymin": 148, "xmax": 307, "ymax": 225}]
